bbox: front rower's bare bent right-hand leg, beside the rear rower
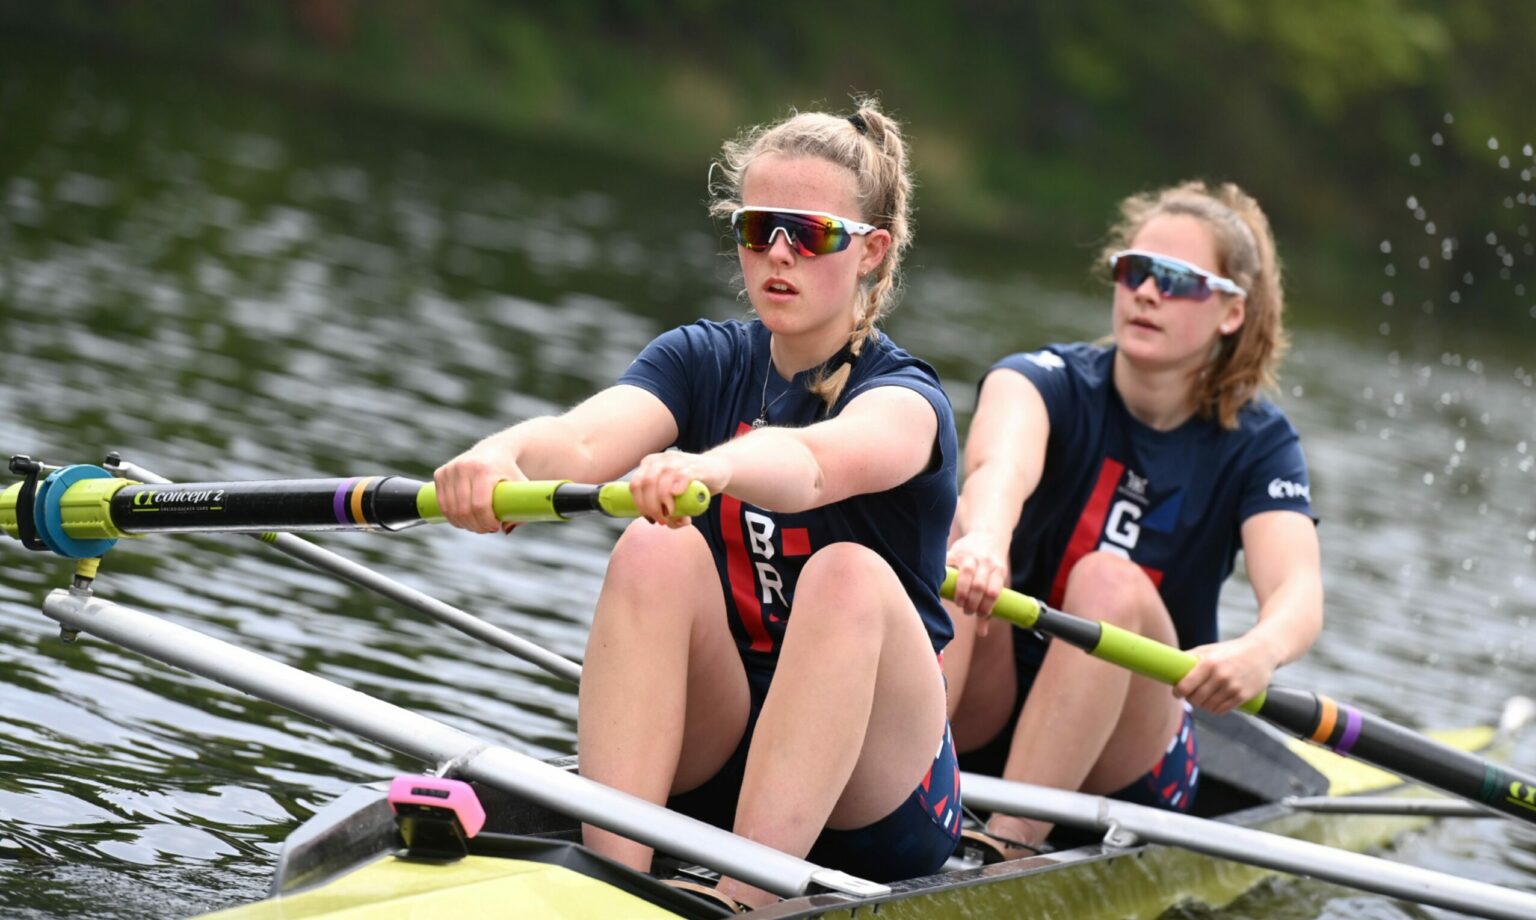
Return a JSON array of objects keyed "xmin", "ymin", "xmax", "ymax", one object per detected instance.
[{"xmin": 720, "ymin": 544, "xmax": 945, "ymax": 905}]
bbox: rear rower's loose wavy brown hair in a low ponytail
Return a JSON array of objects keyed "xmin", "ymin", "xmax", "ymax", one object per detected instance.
[{"xmin": 1100, "ymin": 181, "xmax": 1290, "ymax": 429}]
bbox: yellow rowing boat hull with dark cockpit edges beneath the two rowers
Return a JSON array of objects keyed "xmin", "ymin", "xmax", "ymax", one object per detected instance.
[{"xmin": 201, "ymin": 717, "xmax": 1495, "ymax": 920}]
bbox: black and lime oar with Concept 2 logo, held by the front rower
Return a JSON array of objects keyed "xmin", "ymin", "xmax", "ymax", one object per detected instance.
[{"xmin": 0, "ymin": 465, "xmax": 710, "ymax": 558}]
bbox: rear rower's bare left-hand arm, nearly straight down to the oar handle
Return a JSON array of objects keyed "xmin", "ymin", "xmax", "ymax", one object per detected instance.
[{"xmin": 949, "ymin": 370, "xmax": 1051, "ymax": 614}]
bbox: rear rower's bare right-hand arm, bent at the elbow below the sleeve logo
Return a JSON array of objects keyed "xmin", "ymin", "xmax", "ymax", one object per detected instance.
[{"xmin": 1177, "ymin": 511, "xmax": 1322, "ymax": 713}]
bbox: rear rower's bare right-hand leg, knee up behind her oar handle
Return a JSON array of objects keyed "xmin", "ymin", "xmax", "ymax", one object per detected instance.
[{"xmin": 988, "ymin": 553, "xmax": 1181, "ymax": 843}]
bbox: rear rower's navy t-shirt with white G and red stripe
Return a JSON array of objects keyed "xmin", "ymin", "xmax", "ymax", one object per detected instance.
[{"xmin": 992, "ymin": 343, "xmax": 1312, "ymax": 648}]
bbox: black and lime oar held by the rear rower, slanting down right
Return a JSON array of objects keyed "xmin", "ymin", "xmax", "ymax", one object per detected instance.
[{"xmin": 942, "ymin": 568, "xmax": 1536, "ymax": 823}]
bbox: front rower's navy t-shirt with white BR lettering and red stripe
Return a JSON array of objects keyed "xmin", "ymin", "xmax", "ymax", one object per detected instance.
[{"xmin": 619, "ymin": 319, "xmax": 958, "ymax": 667}]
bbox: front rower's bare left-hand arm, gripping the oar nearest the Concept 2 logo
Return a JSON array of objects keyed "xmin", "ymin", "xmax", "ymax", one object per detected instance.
[{"xmin": 433, "ymin": 384, "xmax": 680, "ymax": 533}]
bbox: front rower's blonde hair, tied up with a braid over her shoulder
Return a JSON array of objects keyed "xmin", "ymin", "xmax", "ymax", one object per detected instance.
[{"xmin": 710, "ymin": 98, "xmax": 912, "ymax": 409}]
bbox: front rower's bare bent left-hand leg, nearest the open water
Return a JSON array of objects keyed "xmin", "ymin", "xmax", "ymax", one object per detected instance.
[{"xmin": 576, "ymin": 521, "xmax": 750, "ymax": 871}]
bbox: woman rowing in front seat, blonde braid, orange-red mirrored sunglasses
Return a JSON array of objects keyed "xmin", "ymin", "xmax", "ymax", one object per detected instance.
[{"xmin": 436, "ymin": 101, "xmax": 960, "ymax": 905}]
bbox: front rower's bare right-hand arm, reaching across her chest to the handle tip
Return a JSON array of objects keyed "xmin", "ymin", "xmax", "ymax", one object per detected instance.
[{"xmin": 630, "ymin": 386, "xmax": 938, "ymax": 519}]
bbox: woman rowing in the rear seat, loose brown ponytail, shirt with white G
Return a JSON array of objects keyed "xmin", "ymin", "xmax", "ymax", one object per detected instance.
[{"xmin": 945, "ymin": 183, "xmax": 1322, "ymax": 855}]
